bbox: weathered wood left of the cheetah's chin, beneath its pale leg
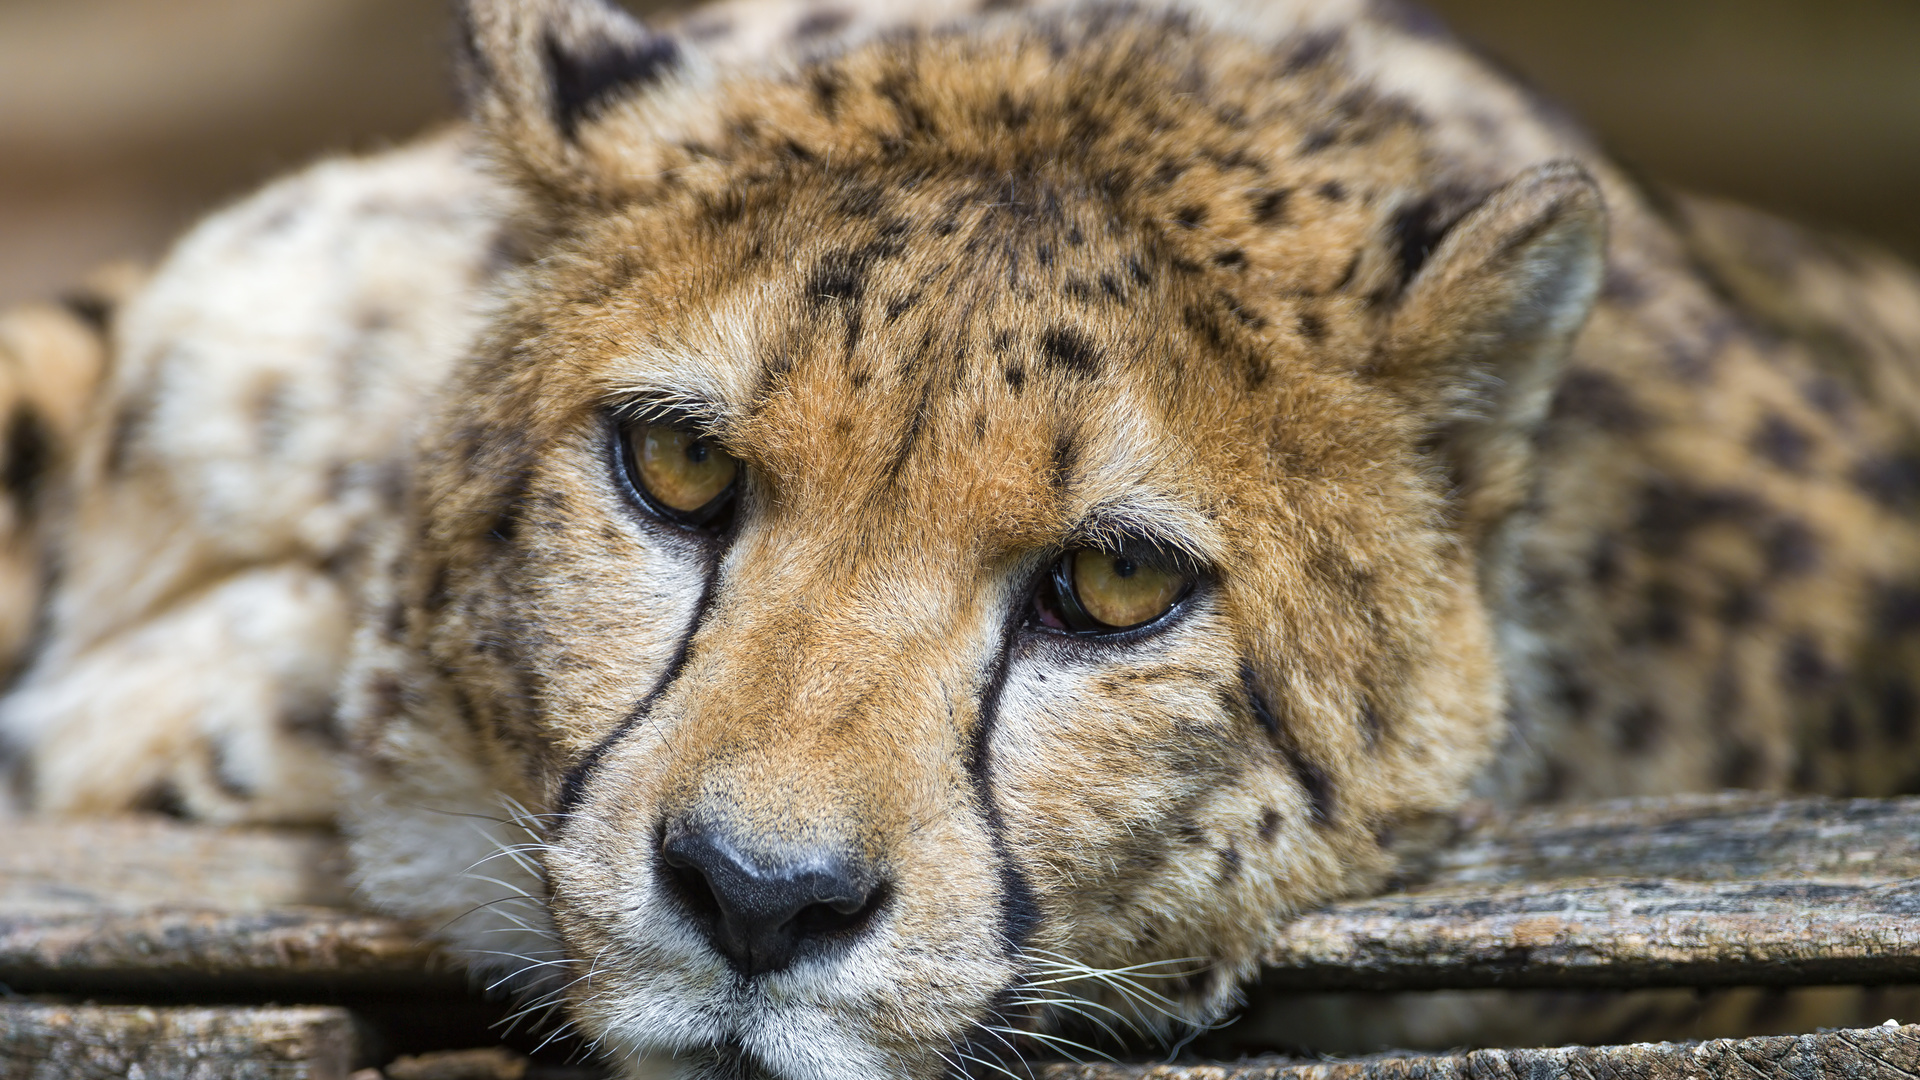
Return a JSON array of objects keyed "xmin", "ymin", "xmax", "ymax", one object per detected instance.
[{"xmin": 0, "ymin": 821, "xmax": 449, "ymax": 992}]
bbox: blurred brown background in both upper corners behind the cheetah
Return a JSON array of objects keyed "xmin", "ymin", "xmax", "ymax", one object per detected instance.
[{"xmin": 0, "ymin": 0, "xmax": 1920, "ymax": 304}]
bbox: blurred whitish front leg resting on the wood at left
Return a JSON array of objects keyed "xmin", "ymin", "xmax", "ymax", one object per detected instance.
[{"xmin": 0, "ymin": 565, "xmax": 349, "ymax": 822}]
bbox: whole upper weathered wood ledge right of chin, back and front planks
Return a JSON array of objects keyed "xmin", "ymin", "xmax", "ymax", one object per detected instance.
[{"xmin": 1263, "ymin": 796, "xmax": 1920, "ymax": 990}]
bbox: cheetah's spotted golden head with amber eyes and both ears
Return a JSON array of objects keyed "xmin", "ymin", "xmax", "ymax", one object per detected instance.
[{"xmin": 349, "ymin": 0, "xmax": 1599, "ymax": 1080}]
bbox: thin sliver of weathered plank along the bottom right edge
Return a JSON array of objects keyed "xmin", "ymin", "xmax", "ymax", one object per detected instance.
[{"xmin": 1039, "ymin": 1026, "xmax": 1920, "ymax": 1080}]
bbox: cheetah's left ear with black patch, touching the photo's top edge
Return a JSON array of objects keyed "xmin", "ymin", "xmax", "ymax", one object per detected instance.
[{"xmin": 459, "ymin": 0, "xmax": 685, "ymax": 202}]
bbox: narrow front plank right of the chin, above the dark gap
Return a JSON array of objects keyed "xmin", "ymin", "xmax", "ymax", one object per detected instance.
[{"xmin": 1261, "ymin": 880, "xmax": 1920, "ymax": 990}]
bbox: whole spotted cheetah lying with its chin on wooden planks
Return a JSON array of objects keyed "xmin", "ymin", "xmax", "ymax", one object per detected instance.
[{"xmin": 0, "ymin": 0, "xmax": 1920, "ymax": 1080}]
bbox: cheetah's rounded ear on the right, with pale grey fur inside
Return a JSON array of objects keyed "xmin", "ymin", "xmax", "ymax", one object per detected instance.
[{"xmin": 1377, "ymin": 161, "xmax": 1607, "ymax": 530}]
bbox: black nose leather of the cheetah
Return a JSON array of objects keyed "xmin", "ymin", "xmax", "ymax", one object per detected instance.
[{"xmin": 660, "ymin": 822, "xmax": 887, "ymax": 974}]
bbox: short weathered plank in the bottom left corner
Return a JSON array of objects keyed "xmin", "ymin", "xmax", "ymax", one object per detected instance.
[{"xmin": 0, "ymin": 1003, "xmax": 359, "ymax": 1080}]
